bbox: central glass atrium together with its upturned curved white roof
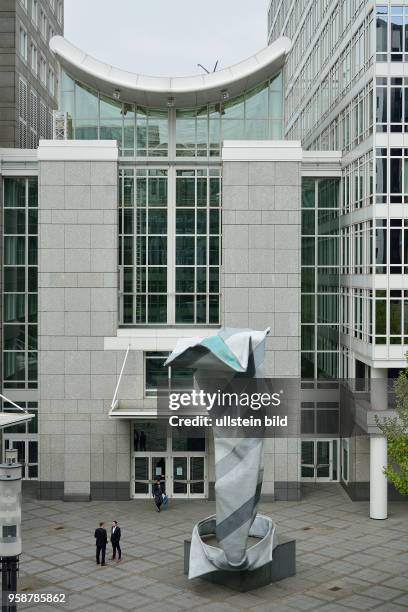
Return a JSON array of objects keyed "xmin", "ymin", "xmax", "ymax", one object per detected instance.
[{"xmin": 55, "ymin": 37, "xmax": 290, "ymax": 326}]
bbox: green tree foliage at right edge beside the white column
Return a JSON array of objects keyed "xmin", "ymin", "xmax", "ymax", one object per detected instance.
[{"xmin": 377, "ymin": 353, "xmax": 408, "ymax": 495}]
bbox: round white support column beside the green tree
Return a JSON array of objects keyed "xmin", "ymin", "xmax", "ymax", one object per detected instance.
[{"xmin": 370, "ymin": 368, "xmax": 388, "ymax": 520}]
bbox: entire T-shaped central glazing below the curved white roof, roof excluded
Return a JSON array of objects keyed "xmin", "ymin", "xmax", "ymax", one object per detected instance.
[{"xmin": 61, "ymin": 73, "xmax": 283, "ymax": 326}]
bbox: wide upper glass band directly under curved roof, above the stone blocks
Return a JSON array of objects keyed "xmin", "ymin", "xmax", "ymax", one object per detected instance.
[{"xmin": 61, "ymin": 73, "xmax": 283, "ymax": 158}]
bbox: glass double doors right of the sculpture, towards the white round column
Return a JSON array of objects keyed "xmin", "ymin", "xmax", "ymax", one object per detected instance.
[{"xmin": 301, "ymin": 440, "xmax": 338, "ymax": 482}]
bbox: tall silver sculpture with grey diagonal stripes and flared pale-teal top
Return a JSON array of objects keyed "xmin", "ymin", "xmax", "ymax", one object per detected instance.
[{"xmin": 166, "ymin": 328, "xmax": 277, "ymax": 578}]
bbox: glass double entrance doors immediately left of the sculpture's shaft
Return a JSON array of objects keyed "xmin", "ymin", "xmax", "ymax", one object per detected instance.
[{"xmin": 173, "ymin": 454, "xmax": 206, "ymax": 498}]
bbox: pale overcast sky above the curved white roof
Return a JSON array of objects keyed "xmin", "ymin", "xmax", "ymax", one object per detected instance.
[{"xmin": 65, "ymin": 0, "xmax": 269, "ymax": 76}]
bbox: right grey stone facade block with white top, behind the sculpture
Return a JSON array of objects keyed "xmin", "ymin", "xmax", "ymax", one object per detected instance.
[{"xmin": 222, "ymin": 141, "xmax": 303, "ymax": 501}]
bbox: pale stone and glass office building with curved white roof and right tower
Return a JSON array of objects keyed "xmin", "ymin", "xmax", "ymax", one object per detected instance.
[{"xmin": 2, "ymin": 1, "xmax": 402, "ymax": 518}]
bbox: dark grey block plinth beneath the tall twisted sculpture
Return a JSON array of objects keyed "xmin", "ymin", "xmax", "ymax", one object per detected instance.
[{"xmin": 184, "ymin": 537, "xmax": 296, "ymax": 593}]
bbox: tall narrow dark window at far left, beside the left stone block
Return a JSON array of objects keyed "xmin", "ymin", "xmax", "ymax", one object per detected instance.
[{"xmin": 3, "ymin": 178, "xmax": 38, "ymax": 389}]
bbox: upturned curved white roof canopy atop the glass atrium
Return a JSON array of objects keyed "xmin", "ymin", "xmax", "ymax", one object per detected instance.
[{"xmin": 50, "ymin": 36, "xmax": 291, "ymax": 107}]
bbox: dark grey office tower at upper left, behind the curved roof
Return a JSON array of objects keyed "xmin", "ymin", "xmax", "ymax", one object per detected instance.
[{"xmin": 0, "ymin": 0, "xmax": 64, "ymax": 149}]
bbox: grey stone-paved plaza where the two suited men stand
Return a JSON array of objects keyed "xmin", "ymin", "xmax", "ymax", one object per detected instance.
[{"xmin": 14, "ymin": 484, "xmax": 408, "ymax": 612}]
